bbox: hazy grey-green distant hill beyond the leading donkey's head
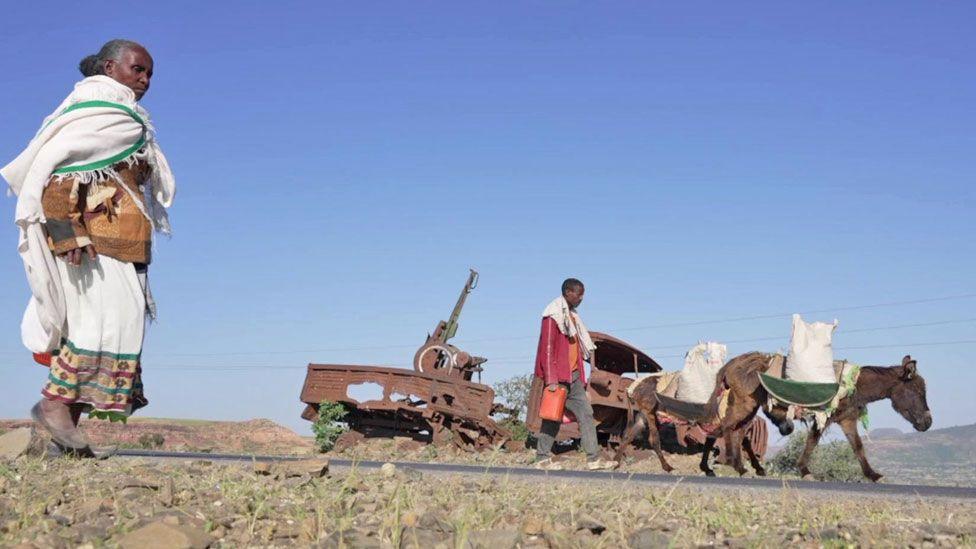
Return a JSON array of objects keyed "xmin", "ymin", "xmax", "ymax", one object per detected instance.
[{"xmin": 865, "ymin": 424, "xmax": 976, "ymax": 486}]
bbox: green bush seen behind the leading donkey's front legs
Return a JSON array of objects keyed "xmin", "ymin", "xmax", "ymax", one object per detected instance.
[{"xmin": 769, "ymin": 429, "xmax": 864, "ymax": 482}]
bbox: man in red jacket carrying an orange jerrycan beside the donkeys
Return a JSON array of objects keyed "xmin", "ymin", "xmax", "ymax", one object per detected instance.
[{"xmin": 535, "ymin": 278, "xmax": 617, "ymax": 470}]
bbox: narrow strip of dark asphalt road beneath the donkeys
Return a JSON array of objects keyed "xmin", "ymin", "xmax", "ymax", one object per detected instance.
[{"xmin": 116, "ymin": 450, "xmax": 976, "ymax": 500}]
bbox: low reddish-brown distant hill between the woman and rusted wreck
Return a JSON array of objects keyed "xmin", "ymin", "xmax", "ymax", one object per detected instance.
[{"xmin": 0, "ymin": 418, "xmax": 314, "ymax": 454}]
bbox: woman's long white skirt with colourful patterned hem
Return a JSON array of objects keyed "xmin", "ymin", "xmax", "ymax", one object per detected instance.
[{"xmin": 41, "ymin": 255, "xmax": 148, "ymax": 419}]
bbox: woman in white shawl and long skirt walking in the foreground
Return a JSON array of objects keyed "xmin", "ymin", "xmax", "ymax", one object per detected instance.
[{"xmin": 0, "ymin": 40, "xmax": 176, "ymax": 453}]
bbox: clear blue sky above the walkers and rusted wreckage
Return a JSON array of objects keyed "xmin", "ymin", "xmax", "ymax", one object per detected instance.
[{"xmin": 0, "ymin": 2, "xmax": 976, "ymax": 440}]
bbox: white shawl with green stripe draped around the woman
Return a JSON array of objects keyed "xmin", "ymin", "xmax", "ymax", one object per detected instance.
[{"xmin": 0, "ymin": 76, "xmax": 176, "ymax": 353}]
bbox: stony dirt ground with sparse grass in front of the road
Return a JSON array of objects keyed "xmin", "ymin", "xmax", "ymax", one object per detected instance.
[{"xmin": 0, "ymin": 457, "xmax": 976, "ymax": 549}]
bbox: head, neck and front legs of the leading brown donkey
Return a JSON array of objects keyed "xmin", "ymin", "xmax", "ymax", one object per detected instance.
[{"xmin": 796, "ymin": 355, "xmax": 932, "ymax": 482}]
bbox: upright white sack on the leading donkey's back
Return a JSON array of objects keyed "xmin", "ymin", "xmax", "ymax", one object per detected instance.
[{"xmin": 784, "ymin": 314, "xmax": 837, "ymax": 383}]
